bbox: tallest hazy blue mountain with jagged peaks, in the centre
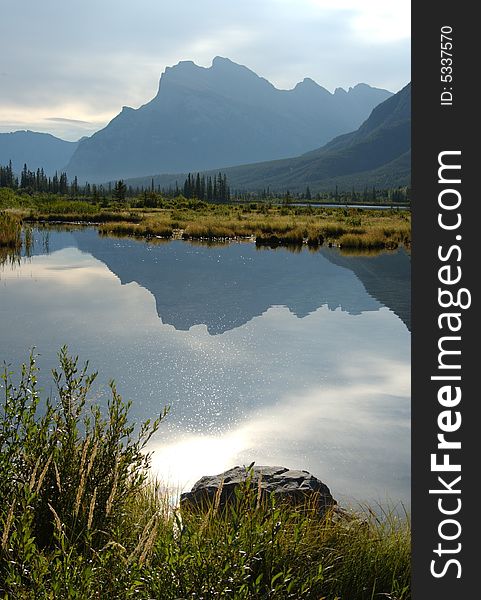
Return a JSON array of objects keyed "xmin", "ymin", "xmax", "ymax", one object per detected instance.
[{"xmin": 68, "ymin": 57, "xmax": 391, "ymax": 182}]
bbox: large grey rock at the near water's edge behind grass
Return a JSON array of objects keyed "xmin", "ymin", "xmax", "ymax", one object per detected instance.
[{"xmin": 180, "ymin": 466, "xmax": 336, "ymax": 513}]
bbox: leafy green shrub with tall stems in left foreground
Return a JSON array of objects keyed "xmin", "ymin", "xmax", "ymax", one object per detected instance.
[{"xmin": 0, "ymin": 348, "xmax": 165, "ymax": 592}]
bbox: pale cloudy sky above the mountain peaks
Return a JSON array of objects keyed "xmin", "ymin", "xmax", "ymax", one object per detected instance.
[{"xmin": 0, "ymin": 0, "xmax": 411, "ymax": 140}]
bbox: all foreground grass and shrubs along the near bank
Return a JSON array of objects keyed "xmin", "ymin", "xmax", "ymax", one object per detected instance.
[{"xmin": 0, "ymin": 348, "xmax": 410, "ymax": 600}]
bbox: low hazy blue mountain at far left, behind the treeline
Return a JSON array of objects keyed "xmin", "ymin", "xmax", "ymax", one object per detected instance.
[{"xmin": 0, "ymin": 131, "xmax": 78, "ymax": 175}]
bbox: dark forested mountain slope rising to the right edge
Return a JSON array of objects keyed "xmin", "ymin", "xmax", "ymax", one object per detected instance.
[{"xmin": 218, "ymin": 84, "xmax": 411, "ymax": 191}]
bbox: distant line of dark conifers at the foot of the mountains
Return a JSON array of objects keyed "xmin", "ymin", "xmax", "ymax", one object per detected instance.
[{"xmin": 0, "ymin": 161, "xmax": 411, "ymax": 207}]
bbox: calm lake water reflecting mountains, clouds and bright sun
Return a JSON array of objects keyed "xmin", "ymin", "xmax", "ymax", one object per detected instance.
[{"xmin": 0, "ymin": 228, "xmax": 410, "ymax": 505}]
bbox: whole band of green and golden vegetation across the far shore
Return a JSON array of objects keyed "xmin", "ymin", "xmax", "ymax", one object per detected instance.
[{"xmin": 0, "ymin": 188, "xmax": 411, "ymax": 251}]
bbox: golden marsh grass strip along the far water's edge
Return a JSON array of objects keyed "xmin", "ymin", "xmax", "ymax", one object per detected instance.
[{"xmin": 96, "ymin": 205, "xmax": 410, "ymax": 248}]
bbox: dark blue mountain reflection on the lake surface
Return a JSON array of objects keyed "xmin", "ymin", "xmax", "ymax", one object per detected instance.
[{"xmin": 58, "ymin": 230, "xmax": 411, "ymax": 335}]
